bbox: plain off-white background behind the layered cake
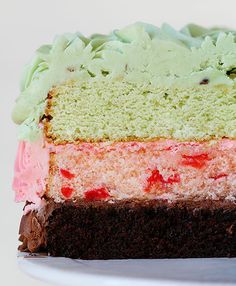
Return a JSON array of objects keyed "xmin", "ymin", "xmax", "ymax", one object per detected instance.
[{"xmin": 0, "ymin": 0, "xmax": 236, "ymax": 286}]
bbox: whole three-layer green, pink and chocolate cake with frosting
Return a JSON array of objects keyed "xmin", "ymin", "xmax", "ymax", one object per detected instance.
[{"xmin": 13, "ymin": 23, "xmax": 236, "ymax": 259}]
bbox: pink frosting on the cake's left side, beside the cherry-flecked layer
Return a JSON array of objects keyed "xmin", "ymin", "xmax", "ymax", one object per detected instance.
[{"xmin": 13, "ymin": 140, "xmax": 49, "ymax": 207}]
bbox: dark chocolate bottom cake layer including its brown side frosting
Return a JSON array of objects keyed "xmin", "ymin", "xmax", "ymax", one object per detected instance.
[{"xmin": 20, "ymin": 201, "xmax": 236, "ymax": 259}]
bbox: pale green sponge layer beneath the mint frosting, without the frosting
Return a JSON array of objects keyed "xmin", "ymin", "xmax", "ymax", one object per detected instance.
[{"xmin": 47, "ymin": 81, "xmax": 236, "ymax": 143}]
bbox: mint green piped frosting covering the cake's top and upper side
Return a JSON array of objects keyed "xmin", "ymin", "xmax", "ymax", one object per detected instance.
[{"xmin": 13, "ymin": 23, "xmax": 236, "ymax": 141}]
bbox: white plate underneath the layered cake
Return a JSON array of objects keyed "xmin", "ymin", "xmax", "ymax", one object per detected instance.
[{"xmin": 18, "ymin": 253, "xmax": 236, "ymax": 286}]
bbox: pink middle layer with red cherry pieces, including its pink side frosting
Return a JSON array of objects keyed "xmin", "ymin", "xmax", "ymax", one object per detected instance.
[{"xmin": 13, "ymin": 139, "xmax": 236, "ymax": 209}]
